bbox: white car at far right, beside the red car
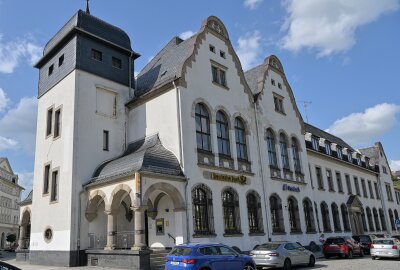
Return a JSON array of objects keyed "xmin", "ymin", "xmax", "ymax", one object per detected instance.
[{"xmin": 371, "ymin": 238, "xmax": 400, "ymax": 260}]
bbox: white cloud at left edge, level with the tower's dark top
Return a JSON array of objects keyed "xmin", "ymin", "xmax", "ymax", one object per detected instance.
[{"xmin": 0, "ymin": 34, "xmax": 42, "ymax": 73}]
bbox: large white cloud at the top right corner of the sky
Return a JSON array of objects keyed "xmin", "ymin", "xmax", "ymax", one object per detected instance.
[{"xmin": 281, "ymin": 0, "xmax": 399, "ymax": 57}]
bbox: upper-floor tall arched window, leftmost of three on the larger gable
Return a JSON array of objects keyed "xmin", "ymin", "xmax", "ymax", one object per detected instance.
[{"xmin": 195, "ymin": 103, "xmax": 211, "ymax": 151}]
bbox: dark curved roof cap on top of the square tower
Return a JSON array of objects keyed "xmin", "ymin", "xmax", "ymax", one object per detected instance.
[{"xmin": 35, "ymin": 10, "xmax": 139, "ymax": 68}]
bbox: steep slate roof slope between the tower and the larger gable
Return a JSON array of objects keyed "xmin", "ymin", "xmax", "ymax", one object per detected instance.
[{"xmin": 133, "ymin": 35, "xmax": 197, "ymax": 100}]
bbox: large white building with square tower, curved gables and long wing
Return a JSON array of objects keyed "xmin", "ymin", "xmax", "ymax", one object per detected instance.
[{"xmin": 17, "ymin": 7, "xmax": 400, "ymax": 269}]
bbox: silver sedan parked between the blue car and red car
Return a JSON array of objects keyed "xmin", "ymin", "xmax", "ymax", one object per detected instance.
[{"xmin": 250, "ymin": 242, "xmax": 315, "ymax": 270}]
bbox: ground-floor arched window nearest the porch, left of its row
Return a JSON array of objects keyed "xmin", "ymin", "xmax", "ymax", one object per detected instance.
[{"xmin": 192, "ymin": 185, "xmax": 214, "ymax": 235}]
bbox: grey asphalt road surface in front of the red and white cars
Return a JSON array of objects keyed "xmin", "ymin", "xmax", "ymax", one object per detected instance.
[{"xmin": 295, "ymin": 256, "xmax": 400, "ymax": 270}]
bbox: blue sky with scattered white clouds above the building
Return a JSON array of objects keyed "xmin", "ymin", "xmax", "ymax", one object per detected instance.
[{"xmin": 0, "ymin": 0, "xmax": 400, "ymax": 196}]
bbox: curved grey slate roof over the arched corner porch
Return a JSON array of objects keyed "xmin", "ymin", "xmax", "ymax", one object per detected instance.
[{"xmin": 84, "ymin": 134, "xmax": 184, "ymax": 187}]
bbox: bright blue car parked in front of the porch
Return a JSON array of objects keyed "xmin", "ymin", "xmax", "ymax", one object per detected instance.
[{"xmin": 165, "ymin": 243, "xmax": 256, "ymax": 270}]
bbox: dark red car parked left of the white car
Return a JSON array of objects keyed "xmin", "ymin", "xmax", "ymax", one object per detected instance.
[{"xmin": 323, "ymin": 236, "xmax": 364, "ymax": 259}]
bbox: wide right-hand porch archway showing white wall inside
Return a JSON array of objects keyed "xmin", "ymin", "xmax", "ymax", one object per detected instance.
[{"xmin": 143, "ymin": 182, "xmax": 186, "ymax": 248}]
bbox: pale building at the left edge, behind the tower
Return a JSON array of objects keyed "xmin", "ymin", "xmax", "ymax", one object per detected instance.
[{"xmin": 0, "ymin": 157, "xmax": 24, "ymax": 249}]
